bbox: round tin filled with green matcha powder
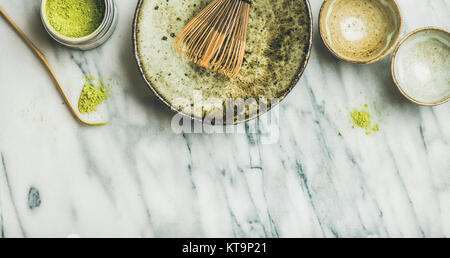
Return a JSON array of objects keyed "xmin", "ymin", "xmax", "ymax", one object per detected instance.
[{"xmin": 41, "ymin": 0, "xmax": 117, "ymax": 50}]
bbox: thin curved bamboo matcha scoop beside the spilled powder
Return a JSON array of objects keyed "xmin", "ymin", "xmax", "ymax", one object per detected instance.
[{"xmin": 0, "ymin": 7, "xmax": 108, "ymax": 126}]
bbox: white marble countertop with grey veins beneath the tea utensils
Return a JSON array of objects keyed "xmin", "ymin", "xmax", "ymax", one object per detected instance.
[{"xmin": 0, "ymin": 0, "xmax": 450, "ymax": 237}]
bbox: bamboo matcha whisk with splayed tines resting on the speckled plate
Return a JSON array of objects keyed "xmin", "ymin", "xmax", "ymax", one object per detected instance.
[{"xmin": 174, "ymin": 0, "xmax": 251, "ymax": 78}]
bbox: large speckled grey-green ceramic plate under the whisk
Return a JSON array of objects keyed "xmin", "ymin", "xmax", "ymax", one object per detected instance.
[{"xmin": 133, "ymin": 0, "xmax": 313, "ymax": 124}]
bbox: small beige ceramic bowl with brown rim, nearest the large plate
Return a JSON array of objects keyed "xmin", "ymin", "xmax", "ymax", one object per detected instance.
[{"xmin": 319, "ymin": 0, "xmax": 402, "ymax": 64}]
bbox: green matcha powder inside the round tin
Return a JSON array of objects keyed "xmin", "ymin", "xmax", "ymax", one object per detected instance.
[{"xmin": 46, "ymin": 0, "xmax": 105, "ymax": 38}]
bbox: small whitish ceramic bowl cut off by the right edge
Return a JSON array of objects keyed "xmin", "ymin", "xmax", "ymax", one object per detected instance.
[{"xmin": 391, "ymin": 27, "xmax": 450, "ymax": 106}]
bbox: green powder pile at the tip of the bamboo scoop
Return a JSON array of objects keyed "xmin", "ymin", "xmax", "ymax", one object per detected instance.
[{"xmin": 78, "ymin": 77, "xmax": 108, "ymax": 114}]
